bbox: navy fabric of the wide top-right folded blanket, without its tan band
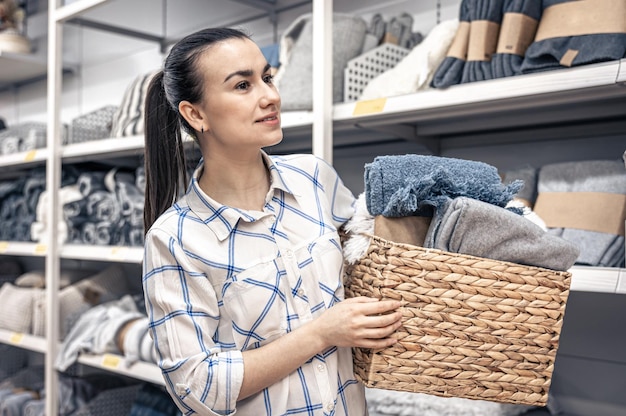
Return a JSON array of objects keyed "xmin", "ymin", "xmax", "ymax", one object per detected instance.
[{"xmin": 520, "ymin": 0, "xmax": 626, "ymax": 74}]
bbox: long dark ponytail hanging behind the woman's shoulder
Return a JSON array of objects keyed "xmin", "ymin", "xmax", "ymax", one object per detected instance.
[{"xmin": 143, "ymin": 71, "xmax": 187, "ymax": 232}]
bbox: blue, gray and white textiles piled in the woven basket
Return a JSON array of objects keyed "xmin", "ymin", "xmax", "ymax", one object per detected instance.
[{"xmin": 344, "ymin": 155, "xmax": 579, "ymax": 270}]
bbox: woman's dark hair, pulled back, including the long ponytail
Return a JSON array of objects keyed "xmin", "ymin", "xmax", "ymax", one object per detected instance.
[{"xmin": 143, "ymin": 28, "xmax": 249, "ymax": 232}]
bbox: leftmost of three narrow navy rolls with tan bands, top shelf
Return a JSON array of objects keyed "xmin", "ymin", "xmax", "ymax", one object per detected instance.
[{"xmin": 431, "ymin": 0, "xmax": 471, "ymax": 88}]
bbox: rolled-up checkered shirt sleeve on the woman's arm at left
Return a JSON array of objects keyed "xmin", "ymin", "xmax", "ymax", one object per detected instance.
[{"xmin": 142, "ymin": 228, "xmax": 244, "ymax": 415}]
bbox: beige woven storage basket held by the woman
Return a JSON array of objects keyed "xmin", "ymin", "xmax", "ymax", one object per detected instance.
[{"xmin": 346, "ymin": 236, "xmax": 571, "ymax": 406}]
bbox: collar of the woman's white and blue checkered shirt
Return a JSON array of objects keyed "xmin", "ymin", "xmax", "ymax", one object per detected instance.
[{"xmin": 185, "ymin": 151, "xmax": 297, "ymax": 241}]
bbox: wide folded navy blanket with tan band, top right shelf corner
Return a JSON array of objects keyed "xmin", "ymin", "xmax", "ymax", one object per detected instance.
[{"xmin": 520, "ymin": 0, "xmax": 626, "ymax": 73}]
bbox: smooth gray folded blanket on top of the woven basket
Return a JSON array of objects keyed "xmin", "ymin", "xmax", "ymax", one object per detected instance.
[{"xmin": 424, "ymin": 197, "xmax": 579, "ymax": 270}]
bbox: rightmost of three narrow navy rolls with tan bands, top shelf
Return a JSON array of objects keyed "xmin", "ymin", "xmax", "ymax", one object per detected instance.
[{"xmin": 491, "ymin": 0, "xmax": 542, "ymax": 78}]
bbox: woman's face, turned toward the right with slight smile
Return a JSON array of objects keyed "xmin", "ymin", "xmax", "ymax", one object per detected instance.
[{"xmin": 199, "ymin": 39, "xmax": 283, "ymax": 149}]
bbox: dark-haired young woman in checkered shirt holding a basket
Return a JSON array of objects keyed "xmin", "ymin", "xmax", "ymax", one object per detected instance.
[{"xmin": 143, "ymin": 29, "xmax": 401, "ymax": 416}]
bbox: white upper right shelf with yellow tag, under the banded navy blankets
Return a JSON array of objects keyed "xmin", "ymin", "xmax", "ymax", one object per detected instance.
[{"xmin": 333, "ymin": 59, "xmax": 626, "ymax": 151}]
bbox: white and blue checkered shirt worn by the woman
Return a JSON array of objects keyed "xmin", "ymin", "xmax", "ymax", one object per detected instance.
[{"xmin": 143, "ymin": 154, "xmax": 367, "ymax": 416}]
